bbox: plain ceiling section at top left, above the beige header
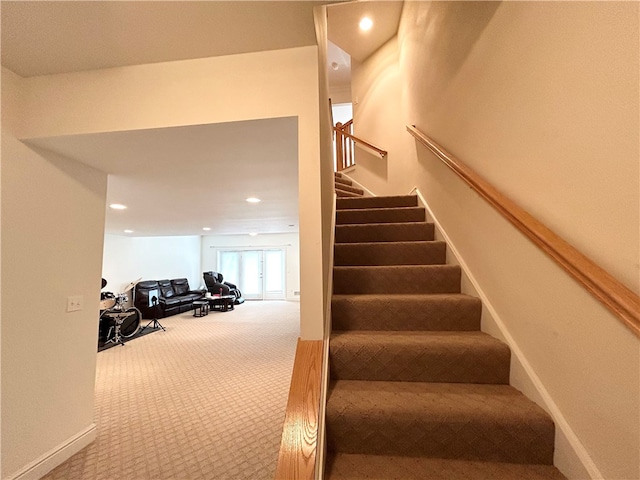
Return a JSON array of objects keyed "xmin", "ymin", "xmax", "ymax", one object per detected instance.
[{"xmin": 1, "ymin": 1, "xmax": 327, "ymax": 77}]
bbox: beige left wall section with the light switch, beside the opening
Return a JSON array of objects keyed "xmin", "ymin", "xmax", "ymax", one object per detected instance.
[{"xmin": 1, "ymin": 67, "xmax": 107, "ymax": 478}]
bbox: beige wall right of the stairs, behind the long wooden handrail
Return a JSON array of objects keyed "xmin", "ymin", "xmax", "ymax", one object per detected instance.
[{"xmin": 352, "ymin": 2, "xmax": 640, "ymax": 479}]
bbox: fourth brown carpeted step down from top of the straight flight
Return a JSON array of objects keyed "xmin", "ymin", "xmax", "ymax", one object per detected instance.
[{"xmin": 333, "ymin": 241, "xmax": 447, "ymax": 265}]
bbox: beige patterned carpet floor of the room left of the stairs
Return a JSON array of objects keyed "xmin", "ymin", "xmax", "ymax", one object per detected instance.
[{"xmin": 44, "ymin": 301, "xmax": 300, "ymax": 480}]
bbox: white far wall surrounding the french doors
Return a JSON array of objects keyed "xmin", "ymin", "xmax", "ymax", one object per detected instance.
[{"xmin": 200, "ymin": 233, "xmax": 303, "ymax": 301}]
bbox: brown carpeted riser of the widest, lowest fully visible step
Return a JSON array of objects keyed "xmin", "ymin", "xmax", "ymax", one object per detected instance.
[{"xmin": 326, "ymin": 407, "xmax": 555, "ymax": 465}]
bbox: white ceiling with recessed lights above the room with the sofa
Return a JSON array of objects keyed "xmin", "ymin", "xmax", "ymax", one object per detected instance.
[{"xmin": 28, "ymin": 117, "xmax": 298, "ymax": 236}]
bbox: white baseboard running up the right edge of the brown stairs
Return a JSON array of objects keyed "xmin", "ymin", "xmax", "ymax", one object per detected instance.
[{"xmin": 410, "ymin": 187, "xmax": 604, "ymax": 480}]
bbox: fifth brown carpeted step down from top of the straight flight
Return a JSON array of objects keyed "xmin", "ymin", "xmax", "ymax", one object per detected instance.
[{"xmin": 333, "ymin": 265, "xmax": 460, "ymax": 294}]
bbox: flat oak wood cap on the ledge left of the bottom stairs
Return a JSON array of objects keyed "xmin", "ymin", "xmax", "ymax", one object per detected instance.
[{"xmin": 275, "ymin": 339, "xmax": 323, "ymax": 480}]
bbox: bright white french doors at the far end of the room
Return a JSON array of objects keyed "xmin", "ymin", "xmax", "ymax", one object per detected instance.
[{"xmin": 218, "ymin": 248, "xmax": 286, "ymax": 300}]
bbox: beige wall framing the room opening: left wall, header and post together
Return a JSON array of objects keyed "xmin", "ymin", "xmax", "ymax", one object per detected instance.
[{"xmin": 2, "ymin": 47, "xmax": 324, "ymax": 476}]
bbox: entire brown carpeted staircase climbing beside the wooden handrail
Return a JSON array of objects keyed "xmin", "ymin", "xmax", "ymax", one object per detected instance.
[{"xmin": 325, "ymin": 183, "xmax": 564, "ymax": 480}]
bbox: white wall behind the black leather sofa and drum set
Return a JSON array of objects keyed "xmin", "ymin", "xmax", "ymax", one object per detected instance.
[{"xmin": 102, "ymin": 235, "xmax": 202, "ymax": 292}]
